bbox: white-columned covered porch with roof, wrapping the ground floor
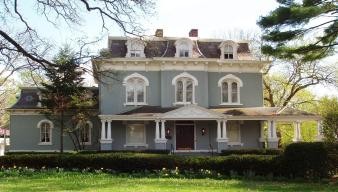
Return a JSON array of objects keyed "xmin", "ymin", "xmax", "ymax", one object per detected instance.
[{"xmin": 99, "ymin": 105, "xmax": 322, "ymax": 152}]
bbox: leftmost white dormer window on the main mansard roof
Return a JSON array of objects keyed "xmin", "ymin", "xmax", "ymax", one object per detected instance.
[{"xmin": 126, "ymin": 39, "xmax": 146, "ymax": 58}]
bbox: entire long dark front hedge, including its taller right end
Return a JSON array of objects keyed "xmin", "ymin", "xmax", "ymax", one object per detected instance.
[{"xmin": 0, "ymin": 142, "xmax": 338, "ymax": 179}]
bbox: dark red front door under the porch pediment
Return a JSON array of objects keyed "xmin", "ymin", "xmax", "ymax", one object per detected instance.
[{"xmin": 176, "ymin": 124, "xmax": 195, "ymax": 150}]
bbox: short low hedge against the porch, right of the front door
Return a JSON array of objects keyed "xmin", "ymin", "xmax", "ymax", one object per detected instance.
[{"xmin": 220, "ymin": 149, "xmax": 283, "ymax": 156}]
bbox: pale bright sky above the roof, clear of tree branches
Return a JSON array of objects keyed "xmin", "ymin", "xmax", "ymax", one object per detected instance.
[{"xmin": 11, "ymin": 0, "xmax": 338, "ymax": 96}]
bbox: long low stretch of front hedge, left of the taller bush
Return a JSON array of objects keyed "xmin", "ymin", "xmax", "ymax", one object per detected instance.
[{"xmin": 0, "ymin": 153, "xmax": 278, "ymax": 176}]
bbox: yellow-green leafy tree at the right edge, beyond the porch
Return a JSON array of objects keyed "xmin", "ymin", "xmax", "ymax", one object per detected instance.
[{"xmin": 317, "ymin": 97, "xmax": 338, "ymax": 142}]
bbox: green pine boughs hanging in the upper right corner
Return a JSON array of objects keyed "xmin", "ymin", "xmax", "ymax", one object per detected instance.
[{"xmin": 258, "ymin": 0, "xmax": 338, "ymax": 61}]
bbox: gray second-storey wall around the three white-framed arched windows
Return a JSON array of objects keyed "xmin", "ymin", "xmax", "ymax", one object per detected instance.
[{"xmin": 99, "ymin": 71, "xmax": 263, "ymax": 114}]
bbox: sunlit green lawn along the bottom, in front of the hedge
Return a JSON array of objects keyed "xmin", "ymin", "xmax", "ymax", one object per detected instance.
[{"xmin": 0, "ymin": 172, "xmax": 338, "ymax": 192}]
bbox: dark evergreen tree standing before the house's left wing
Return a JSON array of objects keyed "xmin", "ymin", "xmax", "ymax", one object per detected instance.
[{"xmin": 41, "ymin": 47, "xmax": 93, "ymax": 153}]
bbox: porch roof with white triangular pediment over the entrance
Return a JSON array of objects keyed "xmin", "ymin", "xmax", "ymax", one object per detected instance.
[{"xmin": 100, "ymin": 105, "xmax": 321, "ymax": 121}]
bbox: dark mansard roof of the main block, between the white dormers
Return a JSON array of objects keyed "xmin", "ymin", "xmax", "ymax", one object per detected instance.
[{"xmin": 109, "ymin": 38, "xmax": 250, "ymax": 58}]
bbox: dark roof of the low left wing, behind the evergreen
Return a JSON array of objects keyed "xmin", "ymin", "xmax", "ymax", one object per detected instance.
[{"xmin": 9, "ymin": 87, "xmax": 99, "ymax": 109}]
